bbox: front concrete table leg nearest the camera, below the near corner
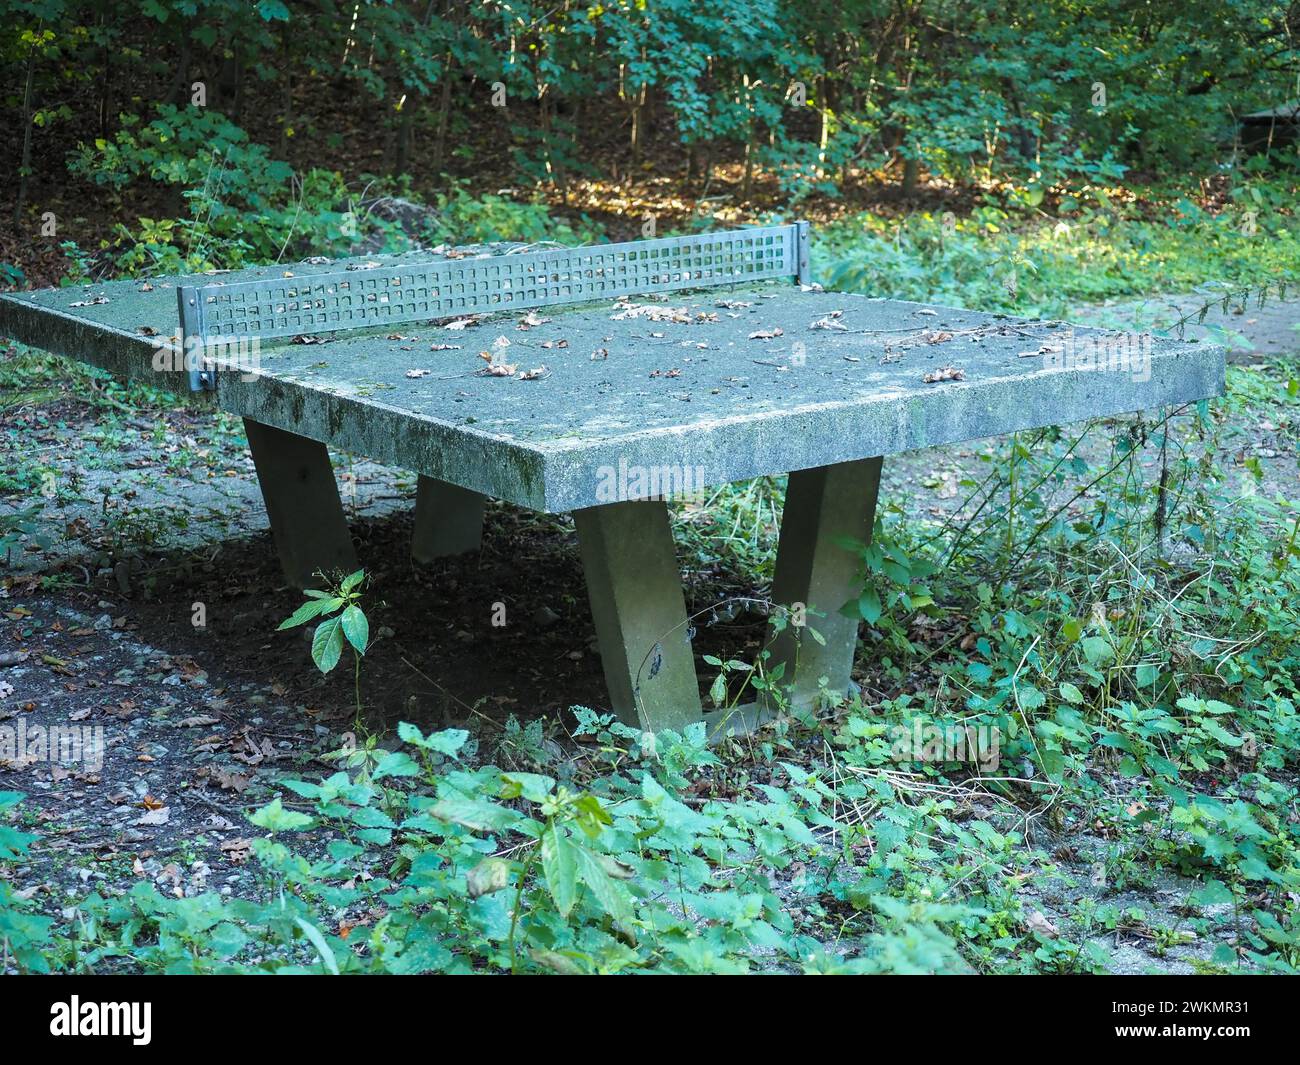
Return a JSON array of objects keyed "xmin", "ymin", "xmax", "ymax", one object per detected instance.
[{"xmin": 573, "ymin": 501, "xmax": 701, "ymax": 731}]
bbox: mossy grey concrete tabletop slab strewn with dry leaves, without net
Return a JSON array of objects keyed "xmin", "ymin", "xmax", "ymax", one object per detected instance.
[{"xmin": 0, "ymin": 252, "xmax": 1225, "ymax": 512}]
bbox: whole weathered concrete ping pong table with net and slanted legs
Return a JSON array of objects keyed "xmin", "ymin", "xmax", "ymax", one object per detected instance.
[{"xmin": 0, "ymin": 222, "xmax": 1225, "ymax": 730}]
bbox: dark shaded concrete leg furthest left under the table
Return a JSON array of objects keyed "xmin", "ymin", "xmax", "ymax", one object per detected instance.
[{"xmin": 244, "ymin": 417, "xmax": 358, "ymax": 589}]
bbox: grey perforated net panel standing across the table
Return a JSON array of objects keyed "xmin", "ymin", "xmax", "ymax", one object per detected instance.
[{"xmin": 189, "ymin": 225, "xmax": 798, "ymax": 338}]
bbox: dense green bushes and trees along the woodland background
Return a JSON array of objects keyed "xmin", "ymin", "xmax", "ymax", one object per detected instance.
[{"xmin": 0, "ymin": 0, "xmax": 1296, "ymax": 211}]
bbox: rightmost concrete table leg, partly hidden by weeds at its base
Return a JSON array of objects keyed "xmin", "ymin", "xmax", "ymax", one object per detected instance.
[{"xmin": 768, "ymin": 459, "xmax": 881, "ymax": 705}]
